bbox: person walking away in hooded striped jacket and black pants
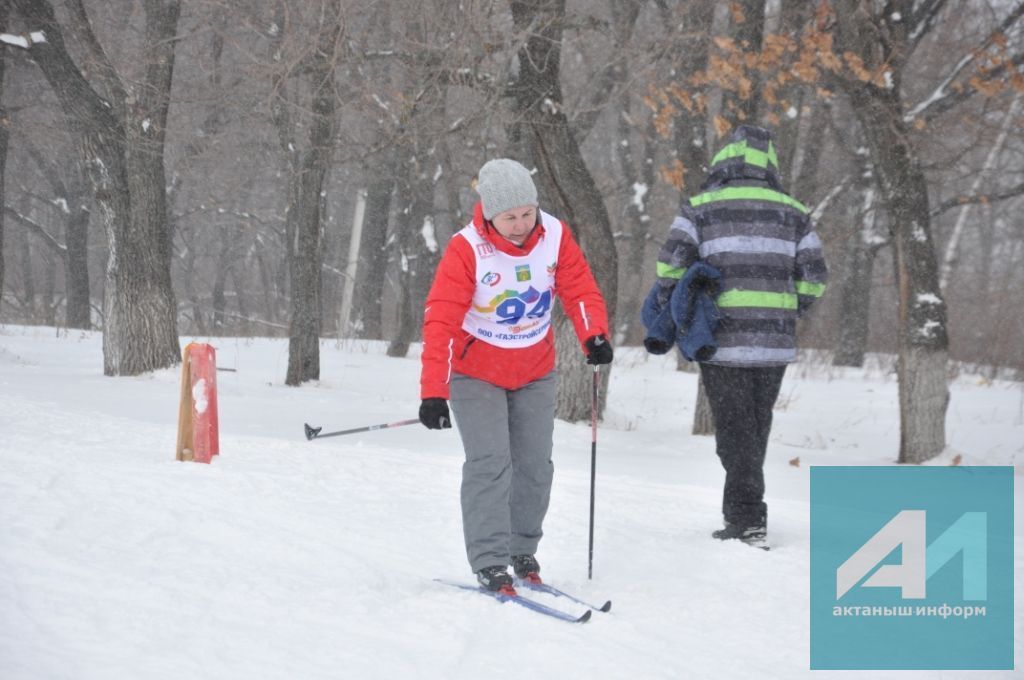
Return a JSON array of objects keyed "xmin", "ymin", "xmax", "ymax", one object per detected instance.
[{"xmin": 645, "ymin": 125, "xmax": 827, "ymax": 547}]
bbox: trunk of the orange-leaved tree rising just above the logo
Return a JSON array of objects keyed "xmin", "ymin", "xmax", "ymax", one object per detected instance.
[{"xmin": 836, "ymin": 0, "xmax": 949, "ymax": 463}]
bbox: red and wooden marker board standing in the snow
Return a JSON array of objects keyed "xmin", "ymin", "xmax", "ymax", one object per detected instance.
[{"xmin": 175, "ymin": 342, "xmax": 220, "ymax": 463}]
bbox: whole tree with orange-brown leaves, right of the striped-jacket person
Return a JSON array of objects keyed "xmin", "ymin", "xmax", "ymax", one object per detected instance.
[{"xmin": 647, "ymin": 0, "xmax": 1024, "ymax": 462}]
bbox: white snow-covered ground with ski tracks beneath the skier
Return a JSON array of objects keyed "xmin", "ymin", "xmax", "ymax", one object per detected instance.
[{"xmin": 0, "ymin": 326, "xmax": 1024, "ymax": 680}]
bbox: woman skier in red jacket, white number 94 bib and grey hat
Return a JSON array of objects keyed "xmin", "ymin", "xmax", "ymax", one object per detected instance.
[{"xmin": 420, "ymin": 159, "xmax": 612, "ymax": 591}]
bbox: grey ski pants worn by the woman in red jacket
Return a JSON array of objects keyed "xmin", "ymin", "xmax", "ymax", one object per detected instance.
[{"xmin": 450, "ymin": 371, "xmax": 558, "ymax": 571}]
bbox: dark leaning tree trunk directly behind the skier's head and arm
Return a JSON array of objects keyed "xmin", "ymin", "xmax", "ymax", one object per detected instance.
[{"xmin": 512, "ymin": 0, "xmax": 618, "ymax": 422}]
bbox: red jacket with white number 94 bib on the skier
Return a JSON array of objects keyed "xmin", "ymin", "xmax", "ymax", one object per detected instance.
[{"xmin": 420, "ymin": 204, "xmax": 608, "ymax": 399}]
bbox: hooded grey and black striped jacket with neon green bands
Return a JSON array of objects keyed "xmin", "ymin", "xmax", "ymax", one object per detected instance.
[{"xmin": 657, "ymin": 126, "xmax": 827, "ymax": 366}]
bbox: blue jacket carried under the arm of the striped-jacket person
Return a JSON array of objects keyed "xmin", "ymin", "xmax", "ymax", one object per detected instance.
[{"xmin": 640, "ymin": 262, "xmax": 722, "ymax": 362}]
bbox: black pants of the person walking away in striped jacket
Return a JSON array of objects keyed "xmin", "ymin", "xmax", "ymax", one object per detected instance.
[{"xmin": 700, "ymin": 364, "xmax": 785, "ymax": 527}]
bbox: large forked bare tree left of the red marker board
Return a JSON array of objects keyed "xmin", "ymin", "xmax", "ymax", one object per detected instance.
[{"xmin": 13, "ymin": 0, "xmax": 180, "ymax": 375}]
